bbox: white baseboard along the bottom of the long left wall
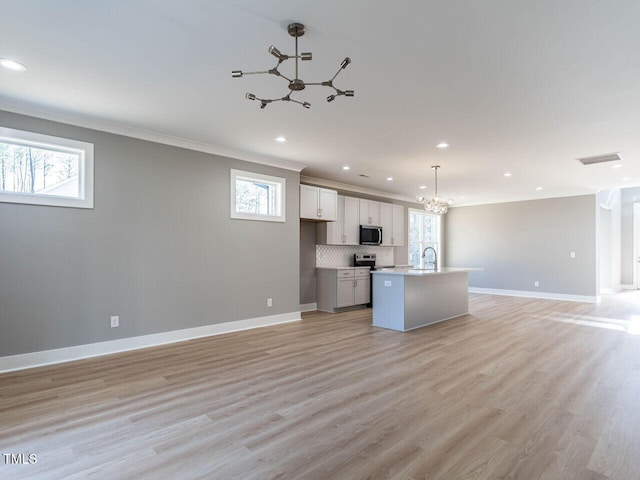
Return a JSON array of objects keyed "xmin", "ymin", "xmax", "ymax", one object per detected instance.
[{"xmin": 0, "ymin": 312, "xmax": 301, "ymax": 373}]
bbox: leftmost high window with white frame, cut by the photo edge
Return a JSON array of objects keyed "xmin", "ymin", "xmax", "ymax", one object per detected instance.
[{"xmin": 0, "ymin": 127, "xmax": 93, "ymax": 208}]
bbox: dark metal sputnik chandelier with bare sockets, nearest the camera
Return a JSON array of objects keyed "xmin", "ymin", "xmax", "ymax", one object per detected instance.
[{"xmin": 231, "ymin": 23, "xmax": 354, "ymax": 108}]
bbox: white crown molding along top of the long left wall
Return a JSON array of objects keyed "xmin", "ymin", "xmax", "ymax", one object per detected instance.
[{"xmin": 0, "ymin": 99, "xmax": 306, "ymax": 172}]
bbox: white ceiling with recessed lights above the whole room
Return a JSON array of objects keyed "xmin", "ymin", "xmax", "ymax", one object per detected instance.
[{"xmin": 0, "ymin": 0, "xmax": 640, "ymax": 205}]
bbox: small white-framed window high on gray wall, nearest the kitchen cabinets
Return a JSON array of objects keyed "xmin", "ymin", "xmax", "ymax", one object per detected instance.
[{"xmin": 231, "ymin": 170, "xmax": 286, "ymax": 222}]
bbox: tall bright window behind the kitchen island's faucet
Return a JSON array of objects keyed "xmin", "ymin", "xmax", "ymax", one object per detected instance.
[{"xmin": 409, "ymin": 208, "xmax": 442, "ymax": 268}]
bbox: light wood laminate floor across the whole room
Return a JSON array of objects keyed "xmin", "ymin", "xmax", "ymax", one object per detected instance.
[{"xmin": 0, "ymin": 292, "xmax": 640, "ymax": 480}]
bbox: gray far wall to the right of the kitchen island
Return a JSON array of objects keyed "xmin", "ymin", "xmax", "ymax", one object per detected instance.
[{"xmin": 444, "ymin": 195, "xmax": 597, "ymax": 296}]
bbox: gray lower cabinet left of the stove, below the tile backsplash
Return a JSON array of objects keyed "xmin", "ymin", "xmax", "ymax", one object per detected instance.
[{"xmin": 316, "ymin": 267, "xmax": 371, "ymax": 312}]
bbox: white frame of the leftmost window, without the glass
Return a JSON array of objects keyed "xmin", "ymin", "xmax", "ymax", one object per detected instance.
[{"xmin": 0, "ymin": 126, "xmax": 94, "ymax": 209}]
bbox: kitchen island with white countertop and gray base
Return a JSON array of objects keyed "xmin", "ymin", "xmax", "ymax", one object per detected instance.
[{"xmin": 372, "ymin": 267, "xmax": 482, "ymax": 332}]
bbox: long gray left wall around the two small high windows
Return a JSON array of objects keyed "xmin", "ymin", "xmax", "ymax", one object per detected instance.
[{"xmin": 0, "ymin": 111, "xmax": 300, "ymax": 356}]
